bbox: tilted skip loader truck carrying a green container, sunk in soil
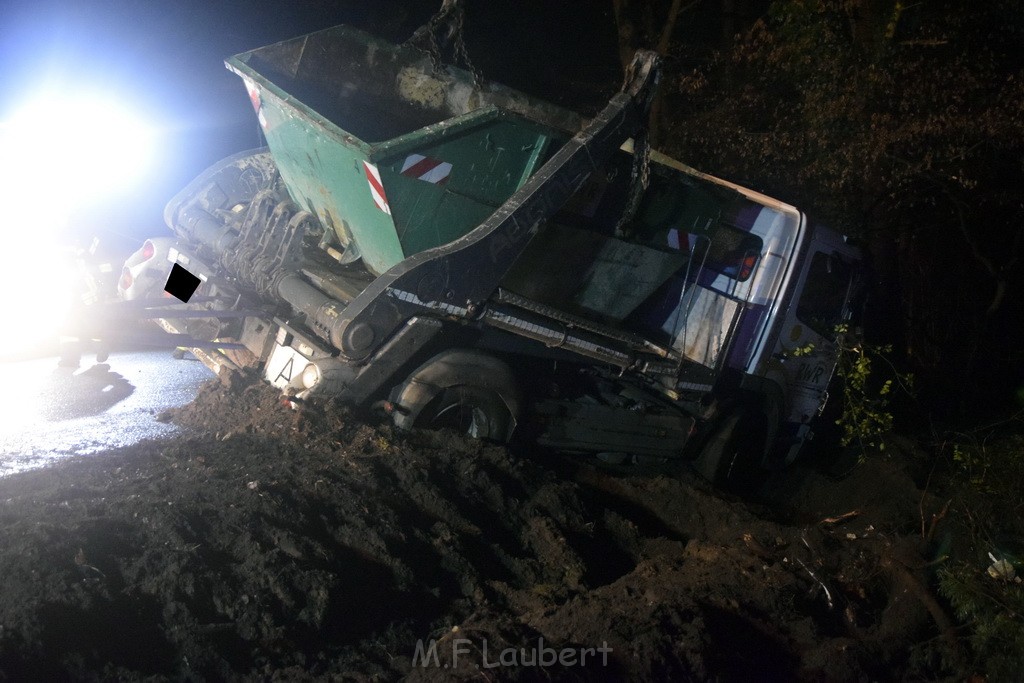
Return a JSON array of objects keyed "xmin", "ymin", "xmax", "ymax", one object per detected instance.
[{"xmin": 119, "ymin": 27, "xmax": 859, "ymax": 482}]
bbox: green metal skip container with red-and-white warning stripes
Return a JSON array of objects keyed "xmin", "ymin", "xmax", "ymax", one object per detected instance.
[{"xmin": 226, "ymin": 26, "xmax": 583, "ymax": 274}]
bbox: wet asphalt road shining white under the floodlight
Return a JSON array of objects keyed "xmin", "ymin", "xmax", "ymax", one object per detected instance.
[{"xmin": 0, "ymin": 350, "xmax": 213, "ymax": 476}]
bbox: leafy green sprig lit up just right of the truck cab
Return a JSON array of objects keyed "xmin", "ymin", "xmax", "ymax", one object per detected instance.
[{"xmin": 836, "ymin": 325, "xmax": 913, "ymax": 451}]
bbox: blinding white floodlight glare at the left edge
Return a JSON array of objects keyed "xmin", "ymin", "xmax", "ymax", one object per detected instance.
[{"xmin": 0, "ymin": 91, "xmax": 155, "ymax": 356}]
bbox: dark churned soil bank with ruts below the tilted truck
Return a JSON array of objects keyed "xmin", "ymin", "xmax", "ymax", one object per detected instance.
[{"xmin": 0, "ymin": 378, "xmax": 958, "ymax": 681}]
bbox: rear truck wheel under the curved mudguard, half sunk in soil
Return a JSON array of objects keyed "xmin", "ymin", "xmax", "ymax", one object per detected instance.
[{"xmin": 415, "ymin": 384, "xmax": 512, "ymax": 441}]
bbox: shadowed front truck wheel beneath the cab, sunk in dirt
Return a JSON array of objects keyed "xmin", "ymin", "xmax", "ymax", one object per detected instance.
[{"xmin": 693, "ymin": 408, "xmax": 768, "ymax": 494}]
